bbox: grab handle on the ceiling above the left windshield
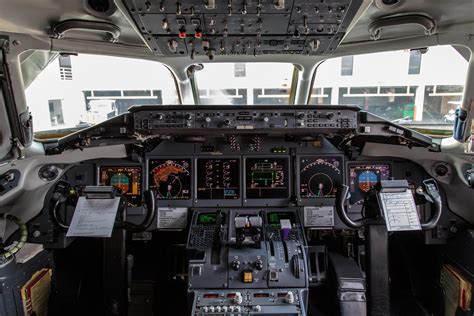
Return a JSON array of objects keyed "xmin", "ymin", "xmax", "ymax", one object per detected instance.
[{"xmin": 53, "ymin": 20, "xmax": 120, "ymax": 43}]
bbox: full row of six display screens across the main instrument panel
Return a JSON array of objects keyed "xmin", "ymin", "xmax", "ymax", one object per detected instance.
[{"xmin": 98, "ymin": 154, "xmax": 392, "ymax": 207}]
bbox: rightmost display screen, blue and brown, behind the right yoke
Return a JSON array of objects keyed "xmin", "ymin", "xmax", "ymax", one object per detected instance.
[{"xmin": 349, "ymin": 164, "xmax": 390, "ymax": 204}]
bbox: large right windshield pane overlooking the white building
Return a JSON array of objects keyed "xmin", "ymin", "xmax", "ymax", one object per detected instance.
[{"xmin": 310, "ymin": 46, "xmax": 468, "ymax": 136}]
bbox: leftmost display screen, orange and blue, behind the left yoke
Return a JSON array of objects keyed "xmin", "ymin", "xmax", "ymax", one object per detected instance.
[{"xmin": 99, "ymin": 166, "xmax": 142, "ymax": 207}]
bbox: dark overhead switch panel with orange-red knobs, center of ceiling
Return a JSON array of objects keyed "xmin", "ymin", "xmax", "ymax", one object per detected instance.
[{"xmin": 125, "ymin": 0, "xmax": 362, "ymax": 60}]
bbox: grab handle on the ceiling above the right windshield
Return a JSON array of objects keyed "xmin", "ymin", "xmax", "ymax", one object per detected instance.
[{"xmin": 369, "ymin": 14, "xmax": 436, "ymax": 41}]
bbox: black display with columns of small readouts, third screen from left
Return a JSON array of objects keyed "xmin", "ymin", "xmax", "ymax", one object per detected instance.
[{"xmin": 196, "ymin": 158, "xmax": 240, "ymax": 200}]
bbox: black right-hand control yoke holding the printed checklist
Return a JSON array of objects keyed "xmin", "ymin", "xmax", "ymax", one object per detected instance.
[{"xmin": 336, "ymin": 179, "xmax": 443, "ymax": 230}]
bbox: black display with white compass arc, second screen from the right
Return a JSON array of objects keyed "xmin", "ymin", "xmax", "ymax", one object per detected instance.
[{"xmin": 299, "ymin": 156, "xmax": 343, "ymax": 199}]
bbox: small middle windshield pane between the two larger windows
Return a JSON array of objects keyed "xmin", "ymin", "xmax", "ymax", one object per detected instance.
[{"xmin": 195, "ymin": 63, "xmax": 294, "ymax": 105}]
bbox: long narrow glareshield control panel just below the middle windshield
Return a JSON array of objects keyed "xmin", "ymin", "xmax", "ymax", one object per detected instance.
[{"xmin": 130, "ymin": 106, "xmax": 358, "ymax": 133}]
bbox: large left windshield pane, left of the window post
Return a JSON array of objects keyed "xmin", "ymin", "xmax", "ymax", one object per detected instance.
[{"xmin": 25, "ymin": 54, "xmax": 178, "ymax": 138}]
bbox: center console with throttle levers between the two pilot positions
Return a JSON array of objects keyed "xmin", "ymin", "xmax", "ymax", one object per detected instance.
[{"xmin": 187, "ymin": 208, "xmax": 308, "ymax": 315}]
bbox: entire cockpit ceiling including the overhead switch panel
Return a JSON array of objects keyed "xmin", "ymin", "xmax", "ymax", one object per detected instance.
[{"xmin": 0, "ymin": 0, "xmax": 474, "ymax": 56}]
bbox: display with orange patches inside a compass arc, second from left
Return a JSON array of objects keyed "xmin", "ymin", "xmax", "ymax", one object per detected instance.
[{"xmin": 148, "ymin": 159, "xmax": 191, "ymax": 200}]
